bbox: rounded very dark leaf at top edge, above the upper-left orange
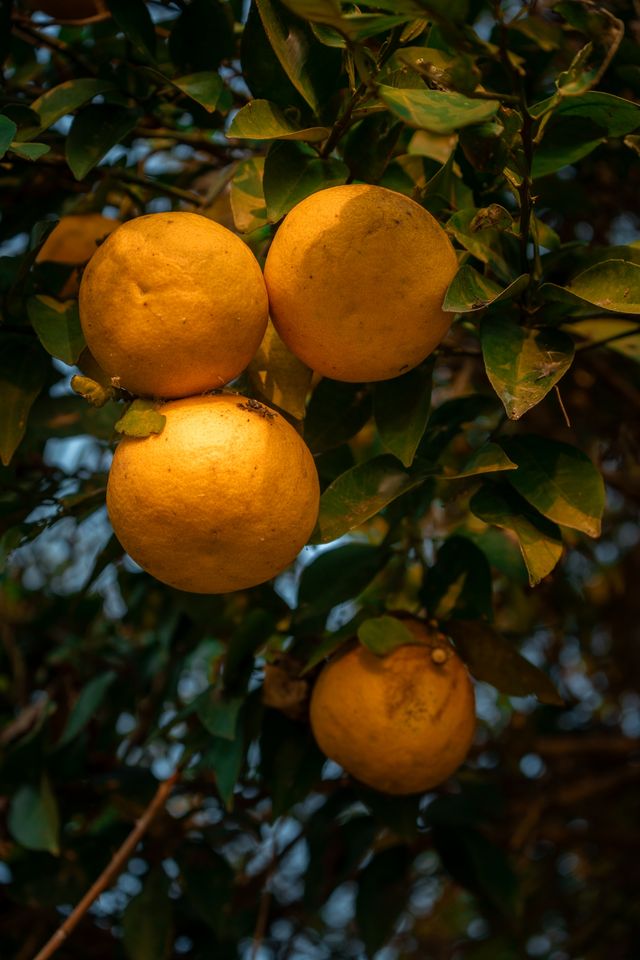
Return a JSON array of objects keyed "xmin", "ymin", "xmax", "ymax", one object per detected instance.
[{"xmin": 169, "ymin": 0, "xmax": 235, "ymax": 73}]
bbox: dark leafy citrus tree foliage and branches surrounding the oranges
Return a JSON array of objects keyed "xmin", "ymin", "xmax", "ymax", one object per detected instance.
[{"xmin": 0, "ymin": 0, "xmax": 640, "ymax": 960}]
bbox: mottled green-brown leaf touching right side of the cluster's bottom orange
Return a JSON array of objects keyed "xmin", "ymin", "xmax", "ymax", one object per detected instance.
[{"xmin": 310, "ymin": 454, "xmax": 423, "ymax": 543}]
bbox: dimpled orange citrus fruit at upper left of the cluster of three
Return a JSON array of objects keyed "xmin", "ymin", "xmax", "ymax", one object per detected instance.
[{"xmin": 80, "ymin": 213, "xmax": 268, "ymax": 398}]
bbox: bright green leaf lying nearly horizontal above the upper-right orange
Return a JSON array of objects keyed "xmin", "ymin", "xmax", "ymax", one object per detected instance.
[{"xmin": 378, "ymin": 84, "xmax": 500, "ymax": 134}]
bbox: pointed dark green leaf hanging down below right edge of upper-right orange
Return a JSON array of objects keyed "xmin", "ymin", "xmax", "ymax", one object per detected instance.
[{"xmin": 373, "ymin": 365, "xmax": 433, "ymax": 467}]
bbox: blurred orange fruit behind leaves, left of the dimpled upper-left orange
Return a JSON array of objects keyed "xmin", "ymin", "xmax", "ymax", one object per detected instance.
[{"xmin": 36, "ymin": 213, "xmax": 119, "ymax": 299}]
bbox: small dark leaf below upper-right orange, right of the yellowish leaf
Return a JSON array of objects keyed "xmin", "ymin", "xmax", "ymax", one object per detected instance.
[{"xmin": 304, "ymin": 377, "xmax": 371, "ymax": 454}]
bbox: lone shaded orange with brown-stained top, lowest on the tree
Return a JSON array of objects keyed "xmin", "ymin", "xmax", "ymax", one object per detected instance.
[{"xmin": 310, "ymin": 620, "xmax": 475, "ymax": 794}]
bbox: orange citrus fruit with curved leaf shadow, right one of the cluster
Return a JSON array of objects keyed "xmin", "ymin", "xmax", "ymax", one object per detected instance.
[{"xmin": 265, "ymin": 184, "xmax": 457, "ymax": 382}]
